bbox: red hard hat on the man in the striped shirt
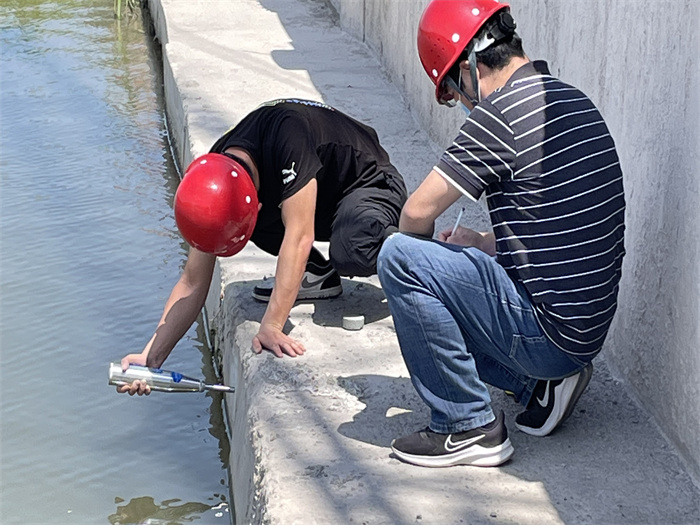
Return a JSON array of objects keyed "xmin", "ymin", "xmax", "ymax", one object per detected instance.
[{"xmin": 418, "ymin": 0, "xmax": 510, "ymax": 102}]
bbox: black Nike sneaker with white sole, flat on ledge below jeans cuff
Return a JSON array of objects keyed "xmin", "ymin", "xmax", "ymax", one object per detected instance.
[{"xmin": 391, "ymin": 412, "xmax": 513, "ymax": 467}]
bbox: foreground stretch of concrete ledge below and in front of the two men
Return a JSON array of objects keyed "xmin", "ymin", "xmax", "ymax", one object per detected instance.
[{"xmin": 214, "ymin": 253, "xmax": 698, "ymax": 525}]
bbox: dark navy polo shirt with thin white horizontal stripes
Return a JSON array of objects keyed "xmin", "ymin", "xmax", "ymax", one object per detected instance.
[{"xmin": 435, "ymin": 61, "xmax": 625, "ymax": 355}]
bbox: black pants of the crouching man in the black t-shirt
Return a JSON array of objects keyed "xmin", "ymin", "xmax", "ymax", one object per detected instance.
[{"xmin": 253, "ymin": 170, "xmax": 407, "ymax": 277}]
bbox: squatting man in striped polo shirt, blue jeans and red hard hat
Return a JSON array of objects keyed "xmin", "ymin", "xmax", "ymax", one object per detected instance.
[{"xmin": 378, "ymin": 0, "xmax": 625, "ymax": 467}]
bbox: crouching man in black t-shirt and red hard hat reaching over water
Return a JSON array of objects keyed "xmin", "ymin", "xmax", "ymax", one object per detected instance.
[{"xmin": 117, "ymin": 99, "xmax": 406, "ymax": 395}]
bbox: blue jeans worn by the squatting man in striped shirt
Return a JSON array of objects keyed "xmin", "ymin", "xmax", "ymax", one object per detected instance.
[{"xmin": 377, "ymin": 233, "xmax": 590, "ymax": 433}]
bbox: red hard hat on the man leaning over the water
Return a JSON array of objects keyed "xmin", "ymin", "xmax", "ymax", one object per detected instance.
[{"xmin": 174, "ymin": 153, "xmax": 258, "ymax": 257}]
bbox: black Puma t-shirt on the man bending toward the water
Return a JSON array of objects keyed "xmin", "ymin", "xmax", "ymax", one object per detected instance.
[{"xmin": 211, "ymin": 99, "xmax": 395, "ymax": 242}]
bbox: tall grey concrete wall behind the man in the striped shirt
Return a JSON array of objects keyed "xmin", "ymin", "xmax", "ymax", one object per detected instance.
[{"xmin": 331, "ymin": 0, "xmax": 700, "ymax": 477}]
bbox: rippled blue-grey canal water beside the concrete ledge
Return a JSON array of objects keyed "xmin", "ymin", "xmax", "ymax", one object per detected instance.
[{"xmin": 0, "ymin": 0, "xmax": 231, "ymax": 525}]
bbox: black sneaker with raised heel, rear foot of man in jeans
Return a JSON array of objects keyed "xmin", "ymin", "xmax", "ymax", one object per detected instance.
[{"xmin": 515, "ymin": 363, "xmax": 593, "ymax": 437}]
